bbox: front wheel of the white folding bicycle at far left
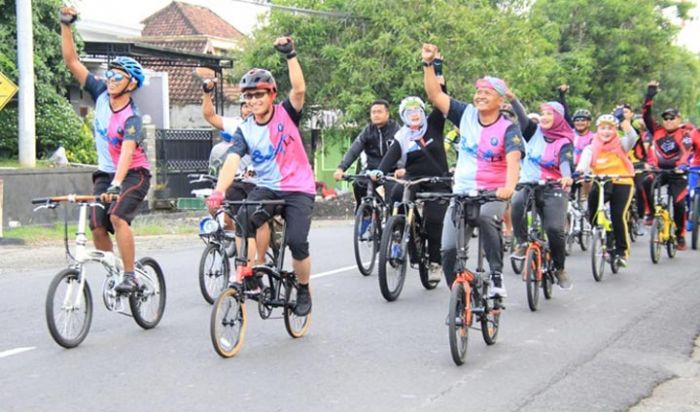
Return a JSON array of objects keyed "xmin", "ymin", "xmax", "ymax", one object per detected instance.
[{"xmin": 45, "ymin": 268, "xmax": 92, "ymax": 349}]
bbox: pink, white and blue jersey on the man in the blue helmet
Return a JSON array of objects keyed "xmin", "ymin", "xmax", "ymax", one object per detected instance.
[{"xmin": 84, "ymin": 74, "xmax": 150, "ymax": 173}]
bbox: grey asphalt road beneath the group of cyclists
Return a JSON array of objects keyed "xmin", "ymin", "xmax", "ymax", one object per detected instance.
[{"xmin": 0, "ymin": 224, "xmax": 700, "ymax": 412}]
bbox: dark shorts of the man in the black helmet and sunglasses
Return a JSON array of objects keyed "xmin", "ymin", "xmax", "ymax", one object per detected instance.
[{"xmin": 236, "ymin": 186, "xmax": 314, "ymax": 260}]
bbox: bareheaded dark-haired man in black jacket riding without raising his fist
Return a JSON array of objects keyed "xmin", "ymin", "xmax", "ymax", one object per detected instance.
[{"xmin": 333, "ymin": 99, "xmax": 400, "ymax": 210}]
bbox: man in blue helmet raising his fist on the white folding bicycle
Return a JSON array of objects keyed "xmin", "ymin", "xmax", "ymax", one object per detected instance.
[{"xmin": 60, "ymin": 6, "xmax": 151, "ymax": 293}]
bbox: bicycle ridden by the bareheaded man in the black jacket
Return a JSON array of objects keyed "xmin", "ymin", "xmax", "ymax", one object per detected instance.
[{"xmin": 343, "ymin": 173, "xmax": 389, "ymax": 276}]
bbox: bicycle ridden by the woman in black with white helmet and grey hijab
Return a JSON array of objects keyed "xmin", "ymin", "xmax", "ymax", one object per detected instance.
[{"xmin": 378, "ymin": 176, "xmax": 452, "ymax": 302}]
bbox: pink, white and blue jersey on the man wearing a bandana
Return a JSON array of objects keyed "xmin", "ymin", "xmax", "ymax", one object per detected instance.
[{"xmin": 447, "ymin": 99, "xmax": 525, "ymax": 194}]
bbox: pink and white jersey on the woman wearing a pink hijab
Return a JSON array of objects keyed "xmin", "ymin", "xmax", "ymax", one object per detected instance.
[{"xmin": 520, "ymin": 126, "xmax": 573, "ymax": 182}]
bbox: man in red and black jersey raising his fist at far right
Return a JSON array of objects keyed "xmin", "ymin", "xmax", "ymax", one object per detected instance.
[{"xmin": 642, "ymin": 81, "xmax": 700, "ymax": 250}]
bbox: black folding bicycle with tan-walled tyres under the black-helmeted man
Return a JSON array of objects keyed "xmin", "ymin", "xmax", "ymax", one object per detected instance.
[{"xmin": 209, "ymin": 200, "xmax": 311, "ymax": 358}]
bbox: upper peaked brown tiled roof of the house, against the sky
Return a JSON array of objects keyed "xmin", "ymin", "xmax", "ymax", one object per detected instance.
[{"xmin": 141, "ymin": 1, "xmax": 243, "ymax": 39}]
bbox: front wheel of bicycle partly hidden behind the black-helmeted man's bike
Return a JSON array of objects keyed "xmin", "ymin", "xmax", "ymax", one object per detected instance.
[{"xmin": 199, "ymin": 243, "xmax": 231, "ymax": 304}]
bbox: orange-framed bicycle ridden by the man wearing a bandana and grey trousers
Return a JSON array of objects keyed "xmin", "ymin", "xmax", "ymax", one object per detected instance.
[{"xmin": 417, "ymin": 190, "xmax": 505, "ymax": 365}]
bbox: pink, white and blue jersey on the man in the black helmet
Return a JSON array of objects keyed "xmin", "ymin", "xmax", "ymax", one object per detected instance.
[{"xmin": 229, "ymin": 99, "xmax": 316, "ymax": 195}]
